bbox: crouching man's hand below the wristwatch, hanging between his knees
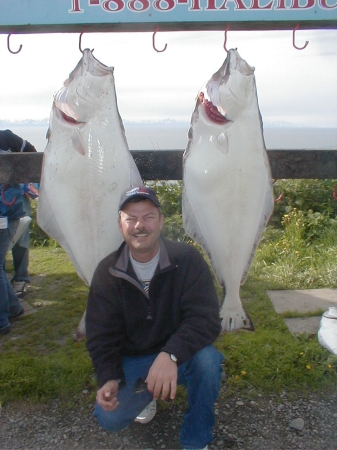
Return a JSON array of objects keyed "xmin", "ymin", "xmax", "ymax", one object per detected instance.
[{"xmin": 146, "ymin": 352, "xmax": 178, "ymax": 400}]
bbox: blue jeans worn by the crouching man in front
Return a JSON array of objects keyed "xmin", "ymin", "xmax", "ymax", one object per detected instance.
[{"xmin": 94, "ymin": 345, "xmax": 225, "ymax": 449}]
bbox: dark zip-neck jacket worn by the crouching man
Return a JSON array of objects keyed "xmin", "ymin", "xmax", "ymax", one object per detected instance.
[{"xmin": 86, "ymin": 240, "xmax": 221, "ymax": 386}]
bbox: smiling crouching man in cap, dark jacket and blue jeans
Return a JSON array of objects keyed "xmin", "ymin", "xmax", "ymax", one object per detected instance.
[{"xmin": 86, "ymin": 186, "xmax": 224, "ymax": 450}]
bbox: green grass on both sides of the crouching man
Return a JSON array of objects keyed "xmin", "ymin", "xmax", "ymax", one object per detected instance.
[{"xmin": 0, "ymin": 209, "xmax": 337, "ymax": 403}]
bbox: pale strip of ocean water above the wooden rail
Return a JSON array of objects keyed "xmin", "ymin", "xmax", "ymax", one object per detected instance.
[{"xmin": 2, "ymin": 123, "xmax": 337, "ymax": 152}]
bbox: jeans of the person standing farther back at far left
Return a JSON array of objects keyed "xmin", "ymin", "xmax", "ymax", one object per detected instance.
[{"xmin": 11, "ymin": 195, "xmax": 30, "ymax": 283}]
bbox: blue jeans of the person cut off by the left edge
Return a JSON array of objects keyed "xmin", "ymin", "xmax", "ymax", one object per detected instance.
[{"xmin": 0, "ymin": 220, "xmax": 22, "ymax": 328}]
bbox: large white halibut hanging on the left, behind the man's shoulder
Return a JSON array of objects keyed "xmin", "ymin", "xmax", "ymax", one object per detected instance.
[{"xmin": 37, "ymin": 49, "xmax": 142, "ymax": 298}]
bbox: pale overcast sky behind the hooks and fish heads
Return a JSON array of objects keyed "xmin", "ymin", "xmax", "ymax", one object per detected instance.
[{"xmin": 0, "ymin": 29, "xmax": 337, "ymax": 127}]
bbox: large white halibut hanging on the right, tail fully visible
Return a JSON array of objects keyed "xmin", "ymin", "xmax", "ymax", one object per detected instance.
[{"xmin": 183, "ymin": 49, "xmax": 274, "ymax": 331}]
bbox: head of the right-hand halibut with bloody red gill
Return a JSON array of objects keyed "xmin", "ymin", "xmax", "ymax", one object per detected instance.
[{"xmin": 198, "ymin": 49, "xmax": 256, "ymax": 125}]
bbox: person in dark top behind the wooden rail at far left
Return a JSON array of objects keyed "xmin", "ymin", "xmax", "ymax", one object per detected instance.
[{"xmin": 0, "ymin": 130, "xmax": 38, "ymax": 296}]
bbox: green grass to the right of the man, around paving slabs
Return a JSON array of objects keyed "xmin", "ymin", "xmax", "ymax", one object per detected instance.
[{"xmin": 219, "ymin": 214, "xmax": 337, "ymax": 393}]
